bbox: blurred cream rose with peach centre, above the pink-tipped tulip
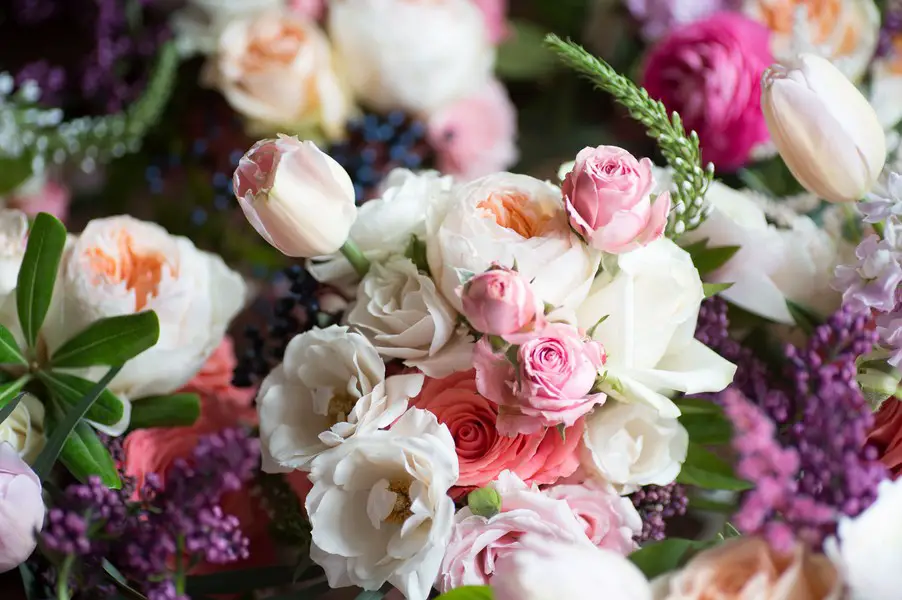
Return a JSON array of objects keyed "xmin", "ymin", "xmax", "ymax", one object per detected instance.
[{"xmin": 205, "ymin": 10, "xmax": 352, "ymax": 138}]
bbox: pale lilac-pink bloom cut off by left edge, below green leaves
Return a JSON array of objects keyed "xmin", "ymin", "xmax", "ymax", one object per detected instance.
[{"xmin": 0, "ymin": 442, "xmax": 44, "ymax": 573}]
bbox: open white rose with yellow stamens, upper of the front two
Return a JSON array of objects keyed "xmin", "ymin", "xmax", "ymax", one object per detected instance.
[{"xmin": 257, "ymin": 325, "xmax": 423, "ymax": 472}]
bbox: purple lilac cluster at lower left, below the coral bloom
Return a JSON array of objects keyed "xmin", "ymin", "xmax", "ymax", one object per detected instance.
[{"xmin": 42, "ymin": 429, "xmax": 259, "ymax": 600}]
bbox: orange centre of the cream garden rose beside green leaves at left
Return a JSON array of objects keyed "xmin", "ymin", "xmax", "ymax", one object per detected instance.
[{"xmin": 85, "ymin": 231, "xmax": 175, "ymax": 311}]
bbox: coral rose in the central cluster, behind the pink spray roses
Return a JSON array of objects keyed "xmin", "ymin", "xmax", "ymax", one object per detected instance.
[{"xmin": 412, "ymin": 371, "xmax": 583, "ymax": 497}]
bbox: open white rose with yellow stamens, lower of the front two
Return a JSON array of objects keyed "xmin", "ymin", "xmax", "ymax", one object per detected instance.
[{"xmin": 306, "ymin": 408, "xmax": 458, "ymax": 600}]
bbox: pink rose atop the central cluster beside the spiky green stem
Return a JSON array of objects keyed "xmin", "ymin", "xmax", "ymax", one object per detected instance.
[{"xmin": 562, "ymin": 146, "xmax": 670, "ymax": 254}]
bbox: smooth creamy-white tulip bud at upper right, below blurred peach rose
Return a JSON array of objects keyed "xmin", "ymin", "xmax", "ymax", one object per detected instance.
[{"xmin": 761, "ymin": 54, "xmax": 886, "ymax": 202}]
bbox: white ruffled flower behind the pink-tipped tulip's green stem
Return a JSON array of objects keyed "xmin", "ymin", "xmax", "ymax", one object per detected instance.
[{"xmin": 307, "ymin": 169, "xmax": 454, "ymax": 295}]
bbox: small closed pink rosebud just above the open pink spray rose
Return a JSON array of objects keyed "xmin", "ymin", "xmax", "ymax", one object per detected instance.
[{"xmin": 461, "ymin": 268, "xmax": 541, "ymax": 335}]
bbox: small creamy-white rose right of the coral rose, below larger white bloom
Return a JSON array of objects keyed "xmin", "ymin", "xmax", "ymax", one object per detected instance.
[{"xmin": 581, "ymin": 400, "xmax": 689, "ymax": 492}]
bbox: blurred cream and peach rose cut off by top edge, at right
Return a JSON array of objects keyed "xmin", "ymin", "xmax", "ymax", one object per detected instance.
[{"xmin": 744, "ymin": 0, "xmax": 880, "ymax": 81}]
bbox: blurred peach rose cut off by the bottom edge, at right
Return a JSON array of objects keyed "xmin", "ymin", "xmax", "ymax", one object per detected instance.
[{"xmin": 652, "ymin": 537, "xmax": 842, "ymax": 600}]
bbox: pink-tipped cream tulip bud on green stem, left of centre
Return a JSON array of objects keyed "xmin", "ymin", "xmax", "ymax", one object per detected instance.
[{"xmin": 233, "ymin": 135, "xmax": 357, "ymax": 258}]
